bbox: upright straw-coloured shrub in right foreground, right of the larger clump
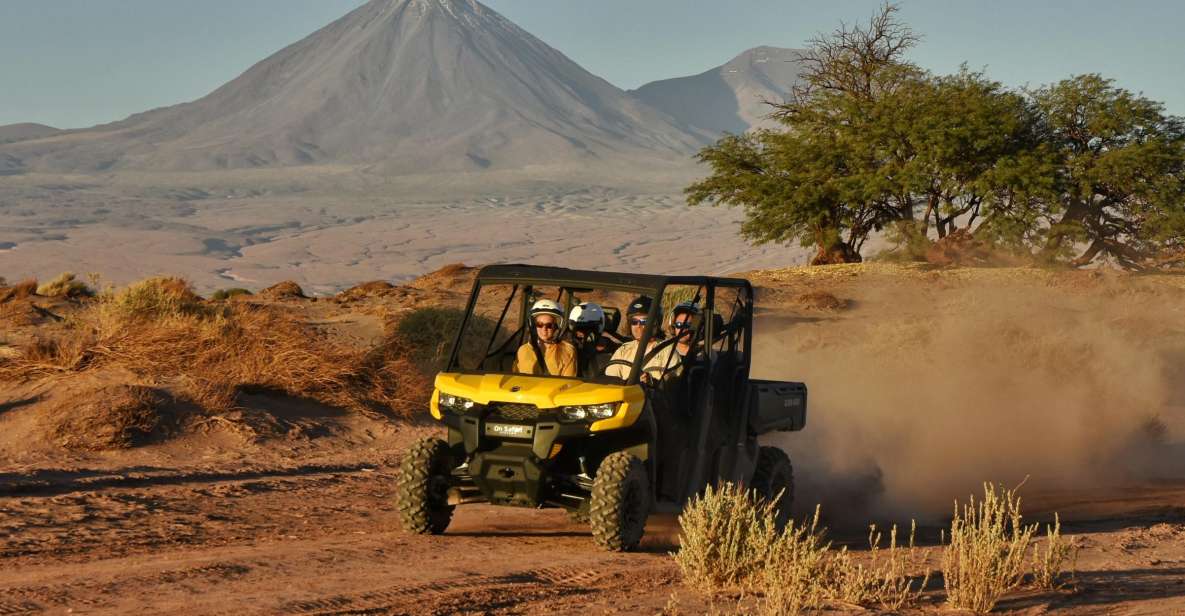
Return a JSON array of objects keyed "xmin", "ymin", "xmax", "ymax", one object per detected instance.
[{"xmin": 942, "ymin": 483, "xmax": 1037, "ymax": 614}]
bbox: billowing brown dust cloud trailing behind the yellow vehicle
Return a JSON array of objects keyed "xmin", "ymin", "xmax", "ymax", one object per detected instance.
[{"xmin": 754, "ymin": 270, "xmax": 1185, "ymax": 522}]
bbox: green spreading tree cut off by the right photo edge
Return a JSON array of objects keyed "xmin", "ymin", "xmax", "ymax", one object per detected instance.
[{"xmin": 1032, "ymin": 75, "xmax": 1185, "ymax": 269}]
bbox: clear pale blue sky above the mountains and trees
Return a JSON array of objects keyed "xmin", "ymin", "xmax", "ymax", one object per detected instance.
[{"xmin": 0, "ymin": 0, "xmax": 1185, "ymax": 128}]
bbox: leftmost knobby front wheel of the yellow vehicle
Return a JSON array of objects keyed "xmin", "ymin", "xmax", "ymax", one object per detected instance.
[{"xmin": 395, "ymin": 438, "xmax": 456, "ymax": 534}]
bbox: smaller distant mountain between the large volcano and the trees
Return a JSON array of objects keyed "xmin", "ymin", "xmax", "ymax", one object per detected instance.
[{"xmin": 630, "ymin": 47, "xmax": 801, "ymax": 134}]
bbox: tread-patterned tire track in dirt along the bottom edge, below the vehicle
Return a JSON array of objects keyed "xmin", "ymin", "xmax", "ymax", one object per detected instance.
[{"xmin": 271, "ymin": 567, "xmax": 611, "ymax": 616}]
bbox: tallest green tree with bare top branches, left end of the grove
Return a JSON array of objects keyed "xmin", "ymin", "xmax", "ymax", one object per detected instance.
[{"xmin": 686, "ymin": 5, "xmax": 923, "ymax": 264}]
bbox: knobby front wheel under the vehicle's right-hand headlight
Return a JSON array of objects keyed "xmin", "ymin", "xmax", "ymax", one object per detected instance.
[{"xmin": 589, "ymin": 451, "xmax": 651, "ymax": 552}]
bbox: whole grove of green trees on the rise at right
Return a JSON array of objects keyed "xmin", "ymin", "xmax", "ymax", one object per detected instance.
[{"xmin": 686, "ymin": 5, "xmax": 1185, "ymax": 268}]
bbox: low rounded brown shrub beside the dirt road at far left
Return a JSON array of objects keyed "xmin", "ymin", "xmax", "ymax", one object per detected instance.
[{"xmin": 50, "ymin": 385, "xmax": 168, "ymax": 451}]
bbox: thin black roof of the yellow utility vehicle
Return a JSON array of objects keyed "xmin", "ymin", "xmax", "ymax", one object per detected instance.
[{"xmin": 478, "ymin": 264, "xmax": 749, "ymax": 291}]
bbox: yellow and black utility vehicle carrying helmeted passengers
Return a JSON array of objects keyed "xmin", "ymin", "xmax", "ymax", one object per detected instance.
[{"xmin": 396, "ymin": 265, "xmax": 807, "ymax": 551}]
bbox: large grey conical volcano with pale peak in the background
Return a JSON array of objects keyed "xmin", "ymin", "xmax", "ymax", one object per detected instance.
[{"xmin": 0, "ymin": 0, "xmax": 706, "ymax": 173}]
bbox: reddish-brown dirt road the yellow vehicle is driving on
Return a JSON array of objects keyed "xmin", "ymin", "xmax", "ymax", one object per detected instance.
[{"xmin": 0, "ymin": 462, "xmax": 1185, "ymax": 616}]
